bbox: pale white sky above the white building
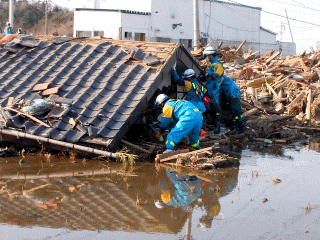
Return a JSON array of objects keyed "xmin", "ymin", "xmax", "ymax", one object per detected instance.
[{"xmin": 52, "ymin": 0, "xmax": 320, "ymax": 54}]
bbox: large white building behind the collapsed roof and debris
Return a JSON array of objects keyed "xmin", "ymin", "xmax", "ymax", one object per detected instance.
[{"xmin": 74, "ymin": 0, "xmax": 296, "ymax": 56}]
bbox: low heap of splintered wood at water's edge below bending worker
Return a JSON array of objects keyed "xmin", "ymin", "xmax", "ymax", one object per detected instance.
[{"xmin": 155, "ymin": 146, "xmax": 237, "ymax": 170}]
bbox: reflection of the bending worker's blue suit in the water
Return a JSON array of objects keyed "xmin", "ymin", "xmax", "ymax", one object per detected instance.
[{"xmin": 160, "ymin": 169, "xmax": 202, "ymax": 208}]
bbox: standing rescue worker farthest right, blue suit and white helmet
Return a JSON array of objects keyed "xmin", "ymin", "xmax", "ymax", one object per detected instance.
[{"xmin": 203, "ymin": 47, "xmax": 243, "ymax": 133}]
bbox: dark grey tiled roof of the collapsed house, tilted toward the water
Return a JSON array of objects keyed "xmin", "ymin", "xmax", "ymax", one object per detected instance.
[{"xmin": 0, "ymin": 37, "xmax": 197, "ymax": 150}]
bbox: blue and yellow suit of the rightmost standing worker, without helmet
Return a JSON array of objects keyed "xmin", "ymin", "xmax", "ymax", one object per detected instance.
[{"xmin": 206, "ymin": 56, "xmax": 242, "ymax": 121}]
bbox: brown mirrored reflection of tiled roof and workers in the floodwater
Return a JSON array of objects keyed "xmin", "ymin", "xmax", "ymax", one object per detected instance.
[{"xmin": 0, "ymin": 155, "xmax": 239, "ymax": 233}]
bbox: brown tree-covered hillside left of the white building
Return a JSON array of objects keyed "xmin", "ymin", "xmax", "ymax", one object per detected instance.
[{"xmin": 0, "ymin": 1, "xmax": 73, "ymax": 36}]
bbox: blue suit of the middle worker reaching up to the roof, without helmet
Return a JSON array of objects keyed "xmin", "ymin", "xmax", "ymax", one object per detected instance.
[{"xmin": 172, "ymin": 70, "xmax": 207, "ymax": 112}]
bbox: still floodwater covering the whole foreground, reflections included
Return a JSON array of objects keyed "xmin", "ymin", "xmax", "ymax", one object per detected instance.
[{"xmin": 0, "ymin": 140, "xmax": 320, "ymax": 239}]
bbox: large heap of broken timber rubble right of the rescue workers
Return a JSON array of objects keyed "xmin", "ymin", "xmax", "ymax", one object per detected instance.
[{"xmin": 193, "ymin": 41, "xmax": 320, "ymax": 142}]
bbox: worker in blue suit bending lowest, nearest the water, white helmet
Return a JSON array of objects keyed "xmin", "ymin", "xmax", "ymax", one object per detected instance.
[{"xmin": 155, "ymin": 94, "xmax": 203, "ymax": 153}]
